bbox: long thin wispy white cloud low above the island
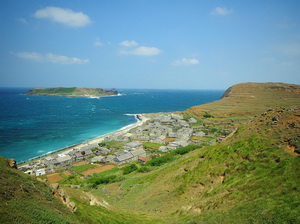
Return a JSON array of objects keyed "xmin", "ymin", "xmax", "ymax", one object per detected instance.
[{"xmin": 16, "ymin": 52, "xmax": 89, "ymax": 65}]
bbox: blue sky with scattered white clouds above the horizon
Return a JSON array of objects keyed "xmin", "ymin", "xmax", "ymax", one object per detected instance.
[{"xmin": 0, "ymin": 0, "xmax": 300, "ymax": 89}]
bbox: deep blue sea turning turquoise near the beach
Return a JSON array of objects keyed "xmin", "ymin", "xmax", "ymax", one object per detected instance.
[{"xmin": 0, "ymin": 88, "xmax": 224, "ymax": 162}]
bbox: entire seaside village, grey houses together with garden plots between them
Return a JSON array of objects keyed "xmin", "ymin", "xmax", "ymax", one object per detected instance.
[{"xmin": 18, "ymin": 113, "xmax": 235, "ymax": 179}]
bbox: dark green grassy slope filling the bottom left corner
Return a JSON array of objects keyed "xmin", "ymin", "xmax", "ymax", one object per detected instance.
[{"xmin": 0, "ymin": 157, "xmax": 76, "ymax": 223}]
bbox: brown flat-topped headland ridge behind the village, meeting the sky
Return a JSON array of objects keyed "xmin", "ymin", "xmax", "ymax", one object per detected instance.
[{"xmin": 186, "ymin": 82, "xmax": 300, "ymax": 118}]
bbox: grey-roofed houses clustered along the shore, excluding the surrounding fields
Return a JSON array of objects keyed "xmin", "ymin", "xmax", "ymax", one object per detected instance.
[{"xmin": 19, "ymin": 114, "xmax": 234, "ymax": 176}]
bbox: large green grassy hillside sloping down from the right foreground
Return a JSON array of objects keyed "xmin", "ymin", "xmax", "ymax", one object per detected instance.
[{"xmin": 85, "ymin": 109, "xmax": 300, "ymax": 223}]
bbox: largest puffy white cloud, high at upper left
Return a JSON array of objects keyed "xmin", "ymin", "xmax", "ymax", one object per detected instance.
[{"xmin": 33, "ymin": 7, "xmax": 91, "ymax": 27}]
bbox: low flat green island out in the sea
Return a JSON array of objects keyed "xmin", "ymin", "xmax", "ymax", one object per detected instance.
[{"xmin": 24, "ymin": 87, "xmax": 118, "ymax": 97}]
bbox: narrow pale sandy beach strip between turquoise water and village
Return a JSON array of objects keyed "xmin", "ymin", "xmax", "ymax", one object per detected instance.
[{"xmin": 18, "ymin": 114, "xmax": 149, "ymax": 166}]
